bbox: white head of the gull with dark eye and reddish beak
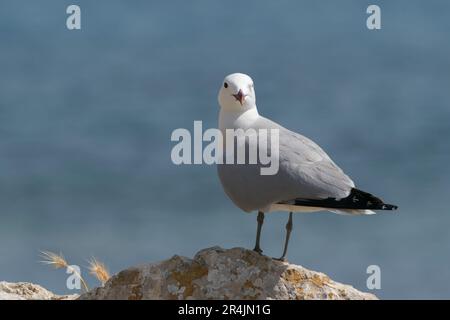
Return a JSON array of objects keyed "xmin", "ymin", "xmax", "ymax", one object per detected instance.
[{"xmin": 218, "ymin": 73, "xmax": 256, "ymax": 111}]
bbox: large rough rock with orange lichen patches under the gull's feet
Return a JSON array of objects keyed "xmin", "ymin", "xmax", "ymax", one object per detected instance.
[{"xmin": 79, "ymin": 247, "xmax": 377, "ymax": 300}]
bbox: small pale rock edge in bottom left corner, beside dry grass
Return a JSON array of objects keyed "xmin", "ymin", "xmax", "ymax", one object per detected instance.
[{"xmin": 0, "ymin": 281, "xmax": 78, "ymax": 300}]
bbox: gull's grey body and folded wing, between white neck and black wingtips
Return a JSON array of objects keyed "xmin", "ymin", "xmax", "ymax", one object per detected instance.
[{"xmin": 218, "ymin": 117, "xmax": 354, "ymax": 211}]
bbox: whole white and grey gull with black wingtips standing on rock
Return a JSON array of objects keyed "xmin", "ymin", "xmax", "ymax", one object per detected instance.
[{"xmin": 217, "ymin": 73, "xmax": 398, "ymax": 261}]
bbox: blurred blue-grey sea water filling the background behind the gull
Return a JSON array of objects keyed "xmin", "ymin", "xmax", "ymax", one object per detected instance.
[{"xmin": 0, "ymin": 0, "xmax": 450, "ymax": 299}]
